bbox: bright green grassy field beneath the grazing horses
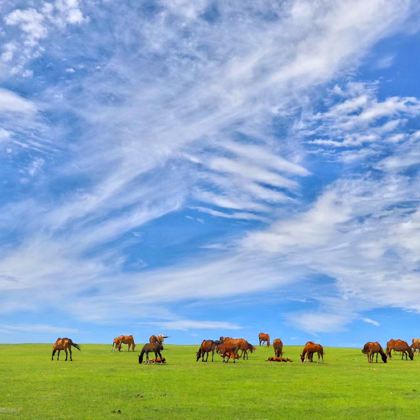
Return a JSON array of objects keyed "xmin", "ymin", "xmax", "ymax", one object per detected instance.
[{"xmin": 0, "ymin": 344, "xmax": 420, "ymax": 419}]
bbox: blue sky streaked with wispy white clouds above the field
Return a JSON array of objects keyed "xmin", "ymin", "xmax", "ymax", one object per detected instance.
[{"xmin": 0, "ymin": 0, "xmax": 420, "ymax": 347}]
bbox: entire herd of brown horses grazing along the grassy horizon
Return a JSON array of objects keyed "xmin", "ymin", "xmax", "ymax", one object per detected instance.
[{"xmin": 51, "ymin": 333, "xmax": 420, "ymax": 363}]
